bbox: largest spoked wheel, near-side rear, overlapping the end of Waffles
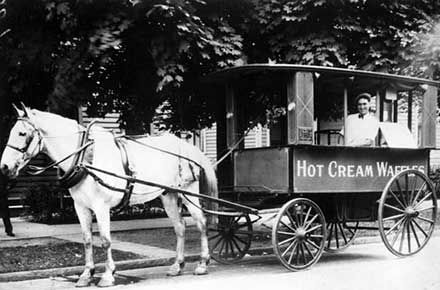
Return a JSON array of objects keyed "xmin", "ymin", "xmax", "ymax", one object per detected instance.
[{"xmin": 378, "ymin": 169, "xmax": 437, "ymax": 256}]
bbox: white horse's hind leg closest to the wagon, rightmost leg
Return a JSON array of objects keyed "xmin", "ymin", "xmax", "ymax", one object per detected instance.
[{"xmin": 182, "ymin": 183, "xmax": 210, "ymax": 275}]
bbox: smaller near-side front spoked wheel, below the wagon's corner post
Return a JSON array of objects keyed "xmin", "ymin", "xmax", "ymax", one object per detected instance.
[{"xmin": 272, "ymin": 198, "xmax": 326, "ymax": 271}]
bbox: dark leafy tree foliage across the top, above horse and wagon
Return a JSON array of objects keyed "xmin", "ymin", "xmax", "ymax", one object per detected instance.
[{"xmin": 0, "ymin": 0, "xmax": 440, "ymax": 137}]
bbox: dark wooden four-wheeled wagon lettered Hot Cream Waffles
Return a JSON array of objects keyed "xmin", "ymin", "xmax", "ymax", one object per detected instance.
[{"xmin": 205, "ymin": 64, "xmax": 440, "ymax": 271}]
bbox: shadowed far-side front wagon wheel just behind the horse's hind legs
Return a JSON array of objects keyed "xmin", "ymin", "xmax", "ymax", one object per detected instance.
[{"xmin": 208, "ymin": 214, "xmax": 252, "ymax": 264}]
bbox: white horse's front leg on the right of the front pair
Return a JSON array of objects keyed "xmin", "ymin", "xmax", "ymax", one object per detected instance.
[{"xmin": 95, "ymin": 205, "xmax": 116, "ymax": 287}]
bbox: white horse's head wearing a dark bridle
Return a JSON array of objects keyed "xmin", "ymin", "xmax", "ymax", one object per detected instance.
[{"xmin": 0, "ymin": 103, "xmax": 43, "ymax": 178}]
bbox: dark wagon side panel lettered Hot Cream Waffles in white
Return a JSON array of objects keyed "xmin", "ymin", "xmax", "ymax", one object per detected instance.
[{"xmin": 291, "ymin": 146, "xmax": 429, "ymax": 193}]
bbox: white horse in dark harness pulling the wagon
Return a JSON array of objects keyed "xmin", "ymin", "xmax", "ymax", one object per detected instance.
[{"xmin": 0, "ymin": 104, "xmax": 217, "ymax": 286}]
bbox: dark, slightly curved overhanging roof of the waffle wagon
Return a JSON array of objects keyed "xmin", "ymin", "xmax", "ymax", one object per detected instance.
[{"xmin": 205, "ymin": 64, "xmax": 440, "ymax": 88}]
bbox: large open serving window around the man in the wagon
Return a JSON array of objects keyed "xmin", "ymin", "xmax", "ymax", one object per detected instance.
[{"xmin": 314, "ymin": 75, "xmax": 424, "ymax": 148}]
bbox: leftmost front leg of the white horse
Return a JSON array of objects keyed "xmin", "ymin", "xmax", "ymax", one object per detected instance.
[{"xmin": 75, "ymin": 202, "xmax": 95, "ymax": 287}]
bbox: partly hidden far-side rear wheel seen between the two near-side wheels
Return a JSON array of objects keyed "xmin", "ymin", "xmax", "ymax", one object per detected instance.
[{"xmin": 324, "ymin": 221, "xmax": 359, "ymax": 253}]
